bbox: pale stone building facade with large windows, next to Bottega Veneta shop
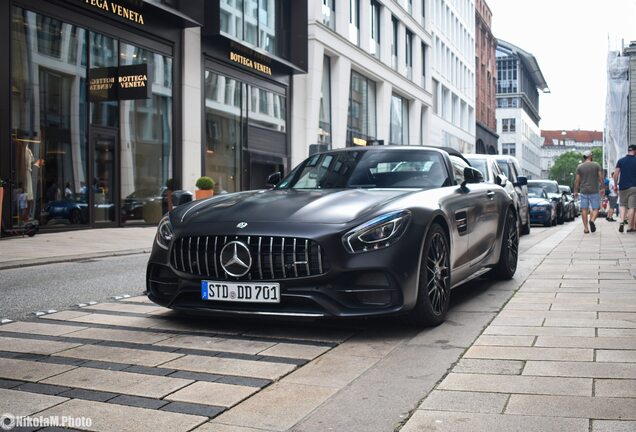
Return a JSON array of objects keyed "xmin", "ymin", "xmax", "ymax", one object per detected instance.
[{"xmin": 292, "ymin": 0, "xmax": 433, "ymax": 164}]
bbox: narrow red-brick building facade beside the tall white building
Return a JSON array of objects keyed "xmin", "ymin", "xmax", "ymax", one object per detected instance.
[{"xmin": 475, "ymin": 0, "xmax": 499, "ymax": 154}]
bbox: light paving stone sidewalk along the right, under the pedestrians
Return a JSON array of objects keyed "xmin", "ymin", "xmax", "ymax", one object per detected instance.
[{"xmin": 401, "ymin": 220, "xmax": 636, "ymax": 432}]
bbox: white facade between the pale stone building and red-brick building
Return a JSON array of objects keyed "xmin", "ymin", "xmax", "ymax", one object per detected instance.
[{"xmin": 430, "ymin": 0, "xmax": 476, "ymax": 153}]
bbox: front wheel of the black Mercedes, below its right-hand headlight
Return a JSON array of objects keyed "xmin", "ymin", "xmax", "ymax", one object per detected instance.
[{"xmin": 408, "ymin": 224, "xmax": 451, "ymax": 327}]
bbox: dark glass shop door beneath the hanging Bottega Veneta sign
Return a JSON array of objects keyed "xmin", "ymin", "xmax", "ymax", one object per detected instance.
[{"xmin": 88, "ymin": 127, "xmax": 120, "ymax": 227}]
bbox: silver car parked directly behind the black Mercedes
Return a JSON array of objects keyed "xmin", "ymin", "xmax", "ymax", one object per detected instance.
[{"xmin": 464, "ymin": 154, "xmax": 530, "ymax": 234}]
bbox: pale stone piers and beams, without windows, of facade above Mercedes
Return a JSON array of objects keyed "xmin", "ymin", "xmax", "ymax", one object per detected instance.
[{"xmin": 291, "ymin": 0, "xmax": 434, "ymax": 165}]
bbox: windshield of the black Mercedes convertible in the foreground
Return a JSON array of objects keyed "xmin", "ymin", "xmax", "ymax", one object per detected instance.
[{"xmin": 276, "ymin": 150, "xmax": 450, "ymax": 189}]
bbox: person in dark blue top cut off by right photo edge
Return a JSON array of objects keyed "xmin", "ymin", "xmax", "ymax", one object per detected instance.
[{"xmin": 614, "ymin": 144, "xmax": 636, "ymax": 232}]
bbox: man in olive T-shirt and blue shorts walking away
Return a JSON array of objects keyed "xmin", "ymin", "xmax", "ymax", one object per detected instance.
[{"xmin": 574, "ymin": 150, "xmax": 604, "ymax": 234}]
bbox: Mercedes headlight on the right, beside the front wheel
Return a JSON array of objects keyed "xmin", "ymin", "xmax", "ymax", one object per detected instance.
[{"xmin": 342, "ymin": 210, "xmax": 411, "ymax": 253}]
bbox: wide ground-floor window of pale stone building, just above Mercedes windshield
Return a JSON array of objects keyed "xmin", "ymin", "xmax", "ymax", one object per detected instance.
[{"xmin": 347, "ymin": 71, "xmax": 377, "ymax": 146}]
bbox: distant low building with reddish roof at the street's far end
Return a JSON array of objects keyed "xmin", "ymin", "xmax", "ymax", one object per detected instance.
[{"xmin": 541, "ymin": 130, "xmax": 603, "ymax": 179}]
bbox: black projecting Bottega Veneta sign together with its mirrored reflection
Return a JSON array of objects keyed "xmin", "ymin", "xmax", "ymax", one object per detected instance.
[{"xmin": 88, "ymin": 63, "xmax": 150, "ymax": 102}]
